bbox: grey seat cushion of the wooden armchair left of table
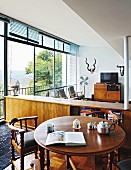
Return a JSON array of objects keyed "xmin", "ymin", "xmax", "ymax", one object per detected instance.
[{"xmin": 17, "ymin": 131, "xmax": 36, "ymax": 148}]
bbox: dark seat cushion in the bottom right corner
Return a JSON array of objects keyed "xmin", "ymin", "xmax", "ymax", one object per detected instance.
[{"xmin": 117, "ymin": 159, "xmax": 131, "ymax": 170}]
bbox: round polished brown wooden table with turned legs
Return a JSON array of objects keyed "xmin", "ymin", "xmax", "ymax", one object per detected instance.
[{"xmin": 34, "ymin": 116, "xmax": 125, "ymax": 170}]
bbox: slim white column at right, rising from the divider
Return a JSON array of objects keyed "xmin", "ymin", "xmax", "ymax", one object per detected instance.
[{"xmin": 124, "ymin": 36, "xmax": 129, "ymax": 109}]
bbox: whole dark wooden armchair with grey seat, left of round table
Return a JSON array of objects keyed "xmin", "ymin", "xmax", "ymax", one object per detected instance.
[{"xmin": 8, "ymin": 116, "xmax": 38, "ymax": 170}]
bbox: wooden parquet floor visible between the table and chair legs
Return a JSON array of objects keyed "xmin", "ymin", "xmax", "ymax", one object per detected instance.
[{"xmin": 4, "ymin": 153, "xmax": 117, "ymax": 170}]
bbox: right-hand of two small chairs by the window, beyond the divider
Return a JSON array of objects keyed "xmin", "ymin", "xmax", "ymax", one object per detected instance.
[{"xmin": 68, "ymin": 86, "xmax": 84, "ymax": 100}]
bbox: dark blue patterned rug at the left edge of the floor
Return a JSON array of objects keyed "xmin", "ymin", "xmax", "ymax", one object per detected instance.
[{"xmin": 0, "ymin": 123, "xmax": 10, "ymax": 170}]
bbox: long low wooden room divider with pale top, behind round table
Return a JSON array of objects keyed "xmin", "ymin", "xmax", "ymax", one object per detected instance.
[{"xmin": 4, "ymin": 95, "xmax": 131, "ymax": 124}]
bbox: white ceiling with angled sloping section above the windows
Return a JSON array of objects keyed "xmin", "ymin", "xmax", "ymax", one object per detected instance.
[{"xmin": 0, "ymin": 0, "xmax": 131, "ymax": 57}]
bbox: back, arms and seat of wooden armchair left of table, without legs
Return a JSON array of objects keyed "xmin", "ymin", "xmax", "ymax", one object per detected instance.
[{"xmin": 8, "ymin": 116, "xmax": 38, "ymax": 152}]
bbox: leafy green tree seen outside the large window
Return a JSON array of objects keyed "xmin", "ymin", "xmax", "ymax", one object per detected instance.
[{"xmin": 25, "ymin": 50, "xmax": 62, "ymax": 95}]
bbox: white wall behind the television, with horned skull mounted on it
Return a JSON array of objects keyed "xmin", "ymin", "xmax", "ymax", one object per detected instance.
[{"xmin": 78, "ymin": 46, "xmax": 126, "ymax": 99}]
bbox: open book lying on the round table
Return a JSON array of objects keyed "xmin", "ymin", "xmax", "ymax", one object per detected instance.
[{"xmin": 45, "ymin": 131, "xmax": 86, "ymax": 146}]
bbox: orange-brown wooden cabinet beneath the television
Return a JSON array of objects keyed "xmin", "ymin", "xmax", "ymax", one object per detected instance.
[{"xmin": 94, "ymin": 83, "xmax": 121, "ymax": 102}]
